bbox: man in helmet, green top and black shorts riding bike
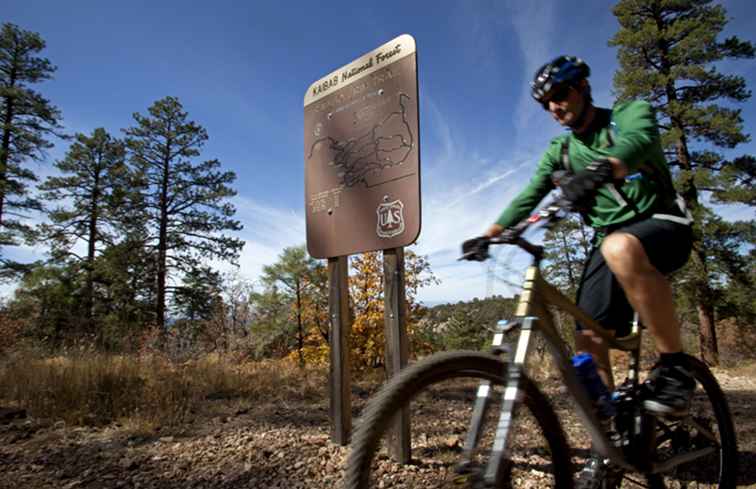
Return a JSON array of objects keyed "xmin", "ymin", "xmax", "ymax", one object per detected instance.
[{"xmin": 463, "ymin": 56, "xmax": 695, "ymax": 416}]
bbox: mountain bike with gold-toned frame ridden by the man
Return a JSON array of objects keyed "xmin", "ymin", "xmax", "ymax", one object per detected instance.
[{"xmin": 345, "ymin": 200, "xmax": 737, "ymax": 489}]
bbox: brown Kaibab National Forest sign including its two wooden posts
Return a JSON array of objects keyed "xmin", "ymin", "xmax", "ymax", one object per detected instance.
[{"xmin": 304, "ymin": 34, "xmax": 420, "ymax": 454}]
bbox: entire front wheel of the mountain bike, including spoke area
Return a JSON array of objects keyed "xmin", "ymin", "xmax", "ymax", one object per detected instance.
[{"xmin": 345, "ymin": 351, "xmax": 573, "ymax": 489}]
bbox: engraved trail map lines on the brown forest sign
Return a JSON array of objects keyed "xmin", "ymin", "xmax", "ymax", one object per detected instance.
[{"xmin": 307, "ymin": 93, "xmax": 415, "ymax": 187}]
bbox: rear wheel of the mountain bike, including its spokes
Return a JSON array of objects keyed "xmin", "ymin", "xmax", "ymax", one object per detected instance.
[{"xmin": 648, "ymin": 357, "xmax": 738, "ymax": 489}]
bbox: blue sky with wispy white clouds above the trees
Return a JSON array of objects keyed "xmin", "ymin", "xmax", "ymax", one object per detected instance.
[{"xmin": 5, "ymin": 0, "xmax": 756, "ymax": 302}]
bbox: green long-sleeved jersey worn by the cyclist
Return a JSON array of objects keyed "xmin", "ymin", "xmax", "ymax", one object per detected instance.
[{"xmin": 496, "ymin": 101, "xmax": 675, "ymax": 228}]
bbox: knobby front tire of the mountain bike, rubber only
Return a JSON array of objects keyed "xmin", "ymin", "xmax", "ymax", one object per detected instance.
[{"xmin": 344, "ymin": 351, "xmax": 573, "ymax": 489}]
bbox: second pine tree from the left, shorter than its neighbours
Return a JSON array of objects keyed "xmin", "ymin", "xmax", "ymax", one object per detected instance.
[{"xmin": 40, "ymin": 128, "xmax": 127, "ymax": 330}]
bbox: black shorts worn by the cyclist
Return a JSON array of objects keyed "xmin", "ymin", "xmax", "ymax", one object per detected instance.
[{"xmin": 577, "ymin": 218, "xmax": 693, "ymax": 337}]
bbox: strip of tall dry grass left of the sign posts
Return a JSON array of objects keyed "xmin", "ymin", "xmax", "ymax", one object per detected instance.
[{"xmin": 0, "ymin": 354, "xmax": 326, "ymax": 427}]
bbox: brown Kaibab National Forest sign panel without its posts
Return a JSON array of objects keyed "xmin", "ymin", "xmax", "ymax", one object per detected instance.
[{"xmin": 304, "ymin": 34, "xmax": 420, "ymax": 258}]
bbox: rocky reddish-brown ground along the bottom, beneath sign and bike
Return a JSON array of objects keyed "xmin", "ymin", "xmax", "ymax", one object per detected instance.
[{"xmin": 0, "ymin": 364, "xmax": 756, "ymax": 489}]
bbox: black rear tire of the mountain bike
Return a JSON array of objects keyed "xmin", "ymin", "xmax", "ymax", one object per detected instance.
[{"xmin": 647, "ymin": 356, "xmax": 738, "ymax": 489}]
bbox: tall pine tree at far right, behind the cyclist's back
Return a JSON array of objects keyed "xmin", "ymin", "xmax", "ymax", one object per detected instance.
[{"xmin": 609, "ymin": 0, "xmax": 754, "ymax": 364}]
